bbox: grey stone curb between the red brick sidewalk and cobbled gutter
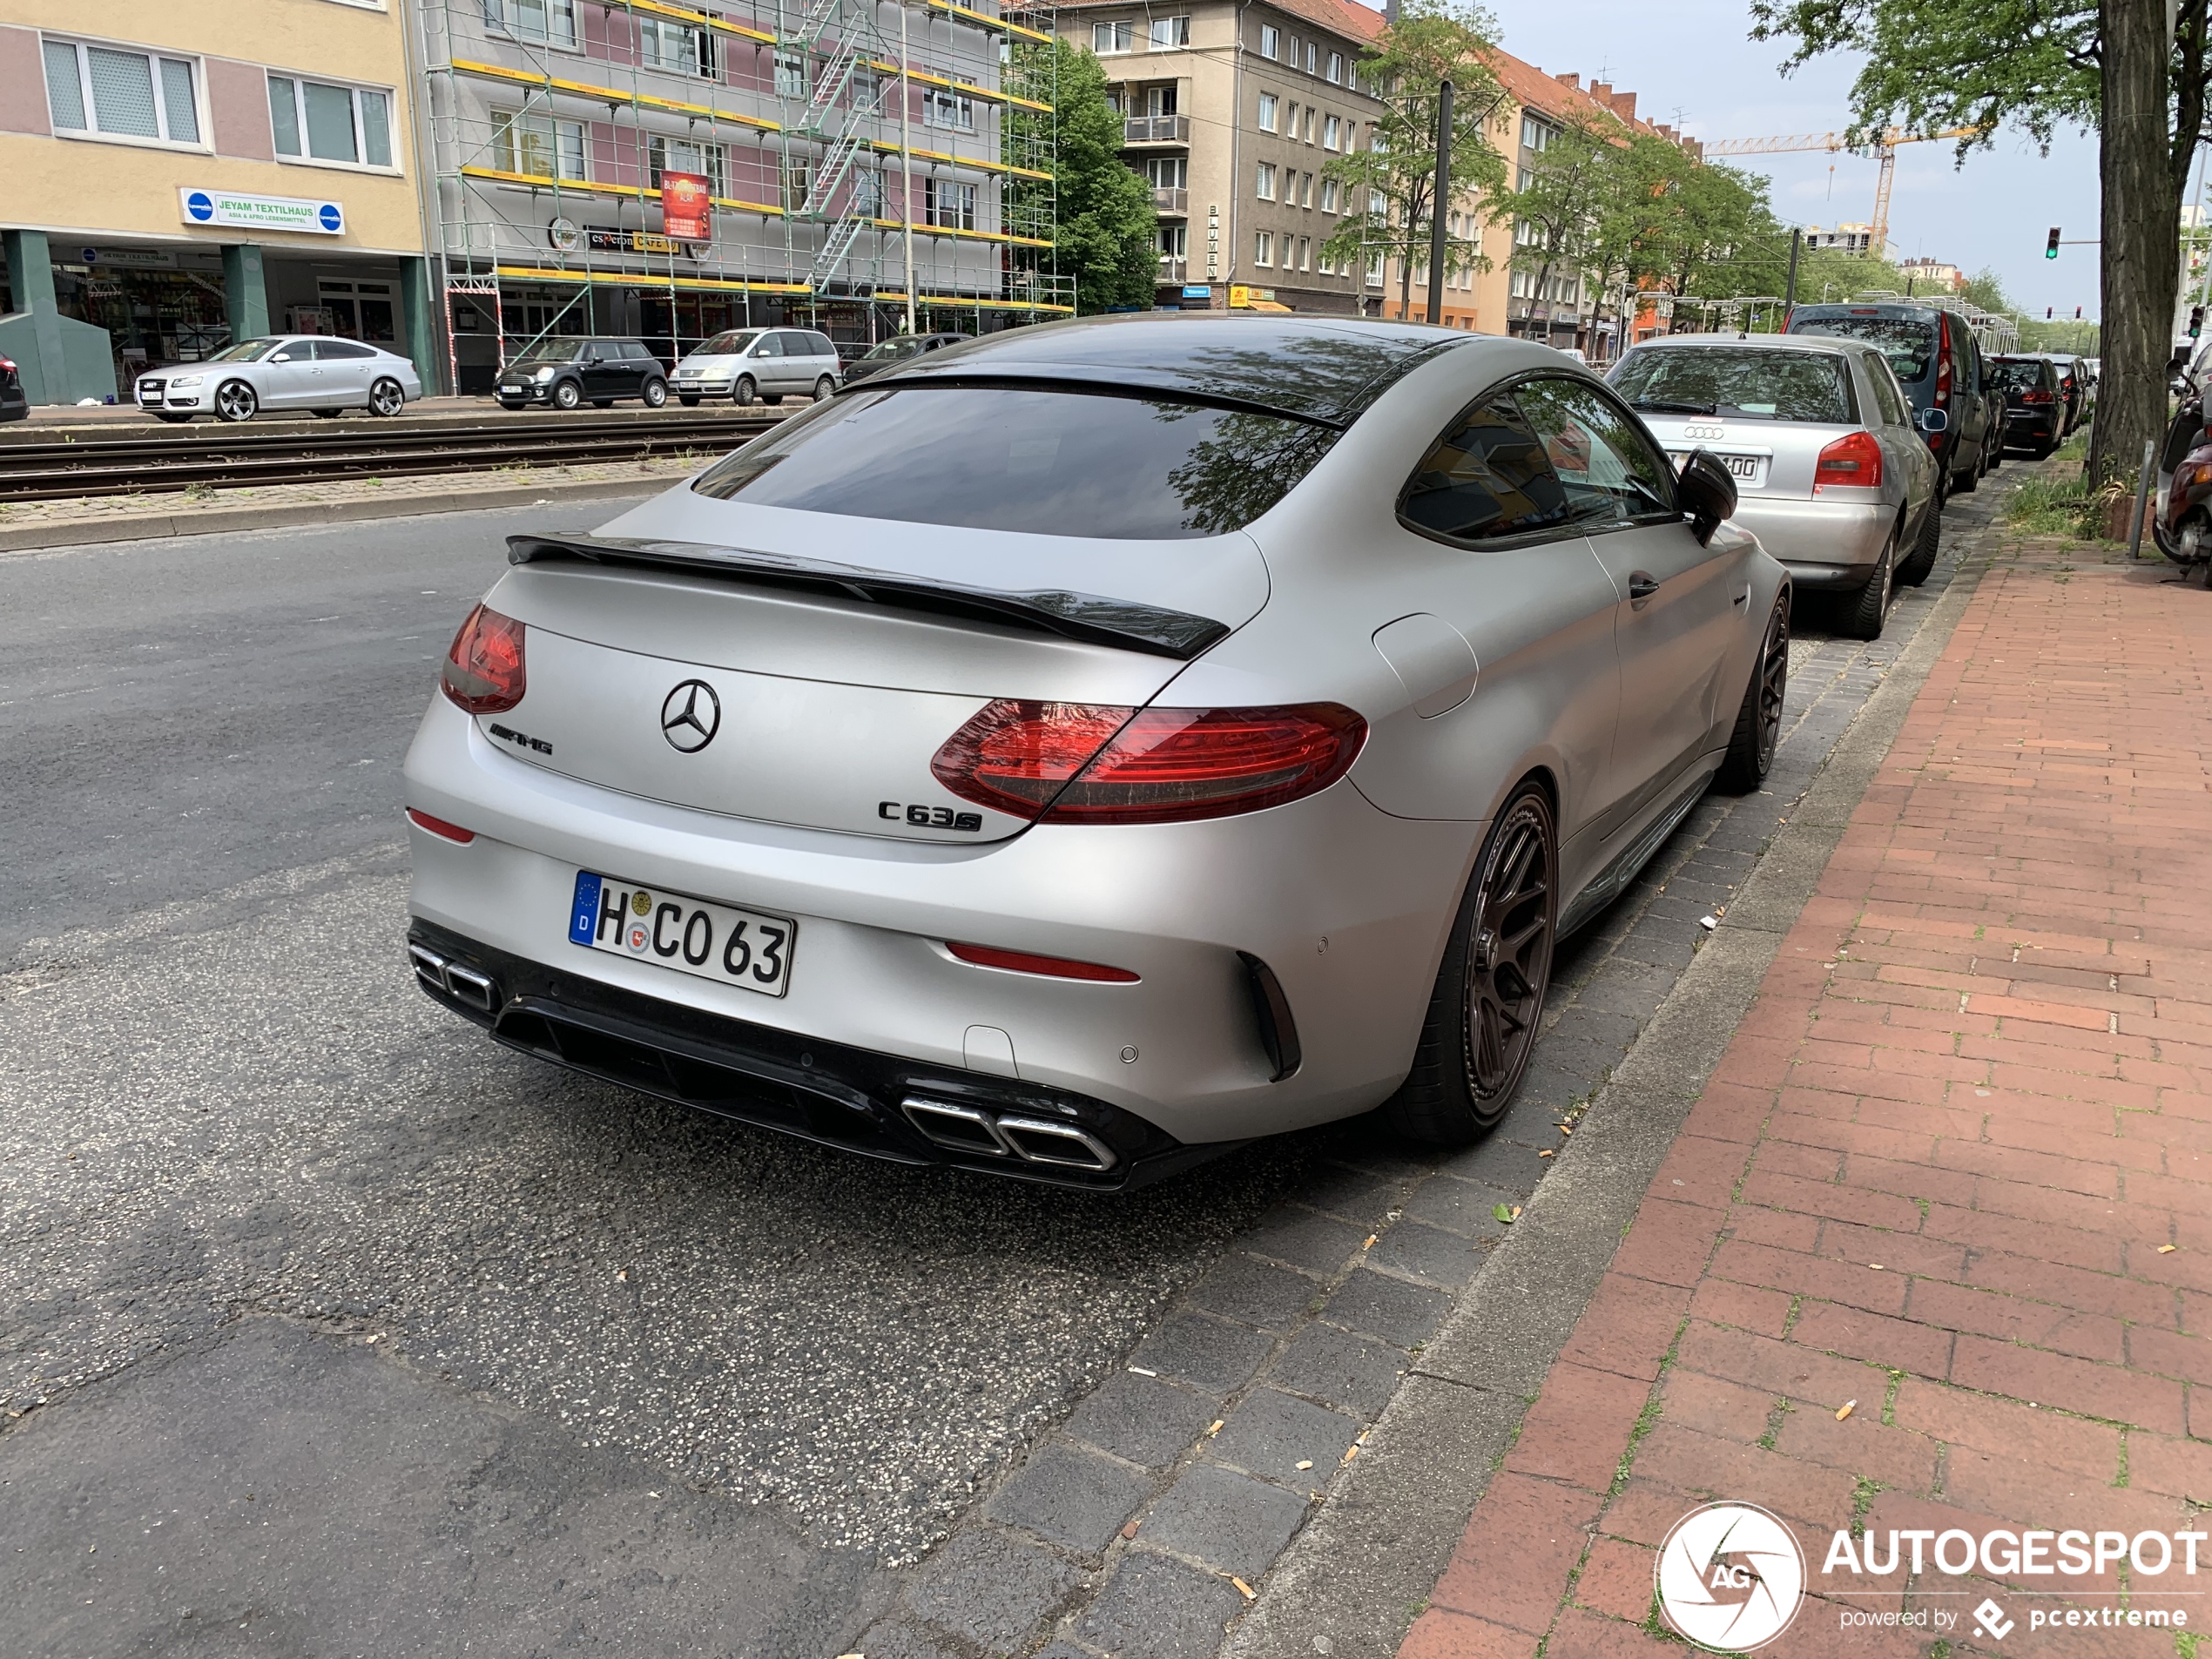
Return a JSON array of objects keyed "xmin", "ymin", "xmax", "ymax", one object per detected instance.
[{"xmin": 1221, "ymin": 522, "xmax": 1995, "ymax": 1659}]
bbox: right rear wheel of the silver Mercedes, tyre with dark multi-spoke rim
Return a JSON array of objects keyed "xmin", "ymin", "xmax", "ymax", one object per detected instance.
[{"xmin": 1383, "ymin": 779, "xmax": 1560, "ymax": 1146}]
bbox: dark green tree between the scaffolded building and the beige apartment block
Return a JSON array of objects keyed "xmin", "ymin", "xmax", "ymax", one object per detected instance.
[{"xmin": 1007, "ymin": 40, "xmax": 1159, "ymax": 316}]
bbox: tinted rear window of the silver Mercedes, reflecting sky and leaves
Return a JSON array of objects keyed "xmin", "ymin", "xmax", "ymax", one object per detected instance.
[{"xmin": 692, "ymin": 388, "xmax": 1336, "ymax": 540}]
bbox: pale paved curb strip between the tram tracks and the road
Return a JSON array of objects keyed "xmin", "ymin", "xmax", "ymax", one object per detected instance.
[{"xmin": 0, "ymin": 455, "xmax": 701, "ymax": 556}]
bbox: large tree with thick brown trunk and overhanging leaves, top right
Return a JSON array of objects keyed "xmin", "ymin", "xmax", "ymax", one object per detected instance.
[{"xmin": 1752, "ymin": 0, "xmax": 2212, "ymax": 480}]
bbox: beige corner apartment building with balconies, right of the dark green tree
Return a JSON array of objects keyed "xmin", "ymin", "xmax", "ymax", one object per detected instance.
[{"xmin": 1057, "ymin": 0, "xmax": 1383, "ymax": 316}]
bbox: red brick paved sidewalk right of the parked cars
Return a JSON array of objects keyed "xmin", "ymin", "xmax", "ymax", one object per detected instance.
[{"xmin": 1400, "ymin": 544, "xmax": 2212, "ymax": 1659}]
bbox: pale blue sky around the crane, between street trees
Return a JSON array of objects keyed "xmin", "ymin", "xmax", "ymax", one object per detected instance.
[{"xmin": 1362, "ymin": 0, "xmax": 2097, "ymax": 319}]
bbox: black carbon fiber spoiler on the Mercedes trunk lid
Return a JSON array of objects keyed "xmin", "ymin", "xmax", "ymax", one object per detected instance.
[{"xmin": 507, "ymin": 536, "xmax": 1230, "ymax": 661}]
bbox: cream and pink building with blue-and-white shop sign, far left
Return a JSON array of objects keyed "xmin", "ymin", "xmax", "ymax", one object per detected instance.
[{"xmin": 0, "ymin": 0, "xmax": 435, "ymax": 402}]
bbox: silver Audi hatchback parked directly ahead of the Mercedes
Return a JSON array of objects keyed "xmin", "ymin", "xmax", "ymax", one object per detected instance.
[{"xmin": 1610, "ymin": 334, "xmax": 1945, "ymax": 639}]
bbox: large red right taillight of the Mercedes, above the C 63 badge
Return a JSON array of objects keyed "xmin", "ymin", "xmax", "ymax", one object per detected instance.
[{"xmin": 929, "ymin": 699, "xmax": 1367, "ymax": 823}]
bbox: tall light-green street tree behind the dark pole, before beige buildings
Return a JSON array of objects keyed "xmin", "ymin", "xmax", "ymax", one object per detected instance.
[{"xmin": 1320, "ymin": 0, "xmax": 1507, "ymax": 314}]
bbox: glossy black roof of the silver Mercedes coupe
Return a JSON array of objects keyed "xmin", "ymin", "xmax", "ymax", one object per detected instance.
[{"xmin": 869, "ymin": 312, "xmax": 1474, "ymax": 427}]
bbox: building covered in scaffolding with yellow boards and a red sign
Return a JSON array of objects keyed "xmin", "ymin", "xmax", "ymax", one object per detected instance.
[{"xmin": 414, "ymin": 0, "xmax": 1075, "ymax": 392}]
